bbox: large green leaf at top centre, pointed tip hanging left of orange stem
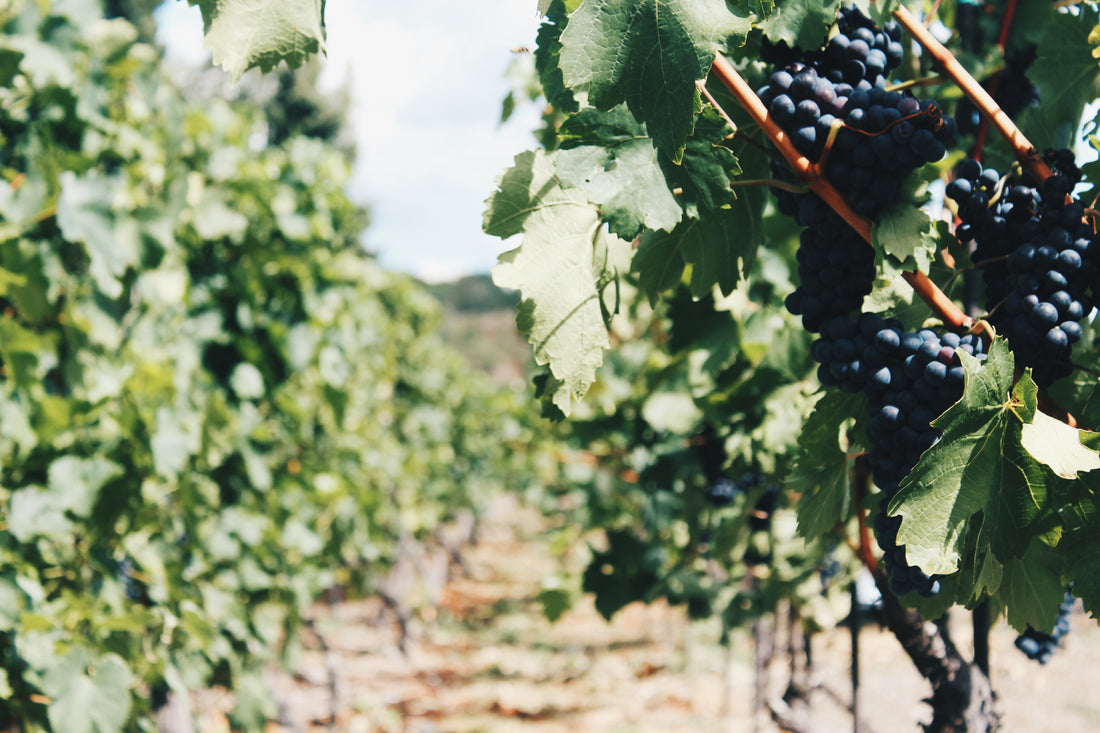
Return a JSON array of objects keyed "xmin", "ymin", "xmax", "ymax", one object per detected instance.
[{"xmin": 561, "ymin": 0, "xmax": 751, "ymax": 163}]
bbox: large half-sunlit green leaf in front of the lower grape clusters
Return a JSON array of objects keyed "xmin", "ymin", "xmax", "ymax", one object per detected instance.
[{"xmin": 890, "ymin": 339, "xmax": 1046, "ymax": 575}]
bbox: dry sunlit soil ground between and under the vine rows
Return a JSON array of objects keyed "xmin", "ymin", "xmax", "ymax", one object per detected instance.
[{"xmin": 197, "ymin": 490, "xmax": 1100, "ymax": 733}]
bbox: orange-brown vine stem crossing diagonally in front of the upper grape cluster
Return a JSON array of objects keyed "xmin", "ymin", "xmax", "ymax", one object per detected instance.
[{"xmin": 711, "ymin": 54, "xmax": 974, "ymax": 329}]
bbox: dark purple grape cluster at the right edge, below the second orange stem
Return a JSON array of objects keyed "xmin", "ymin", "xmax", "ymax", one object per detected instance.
[{"xmin": 947, "ymin": 160, "xmax": 1100, "ymax": 387}]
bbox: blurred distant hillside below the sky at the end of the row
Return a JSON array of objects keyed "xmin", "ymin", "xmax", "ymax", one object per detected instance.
[{"xmin": 425, "ymin": 274, "xmax": 531, "ymax": 384}]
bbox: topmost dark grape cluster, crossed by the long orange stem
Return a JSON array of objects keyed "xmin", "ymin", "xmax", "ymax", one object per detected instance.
[{"xmin": 758, "ymin": 6, "xmax": 955, "ymax": 332}]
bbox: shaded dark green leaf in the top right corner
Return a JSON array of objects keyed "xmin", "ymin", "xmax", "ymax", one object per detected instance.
[{"xmin": 1019, "ymin": 4, "xmax": 1100, "ymax": 150}]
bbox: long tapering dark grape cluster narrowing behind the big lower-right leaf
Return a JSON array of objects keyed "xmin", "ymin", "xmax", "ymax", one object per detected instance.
[{"xmin": 810, "ymin": 314, "xmax": 985, "ymax": 595}]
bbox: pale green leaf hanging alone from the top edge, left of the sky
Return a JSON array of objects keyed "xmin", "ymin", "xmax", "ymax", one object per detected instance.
[{"xmin": 187, "ymin": 0, "xmax": 325, "ymax": 81}]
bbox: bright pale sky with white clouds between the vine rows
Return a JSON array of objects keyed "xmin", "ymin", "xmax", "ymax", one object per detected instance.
[{"xmin": 157, "ymin": 0, "xmax": 539, "ymax": 282}]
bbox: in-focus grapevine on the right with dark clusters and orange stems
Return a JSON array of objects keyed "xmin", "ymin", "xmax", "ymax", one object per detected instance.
[{"xmin": 485, "ymin": 0, "xmax": 1100, "ymax": 722}]
